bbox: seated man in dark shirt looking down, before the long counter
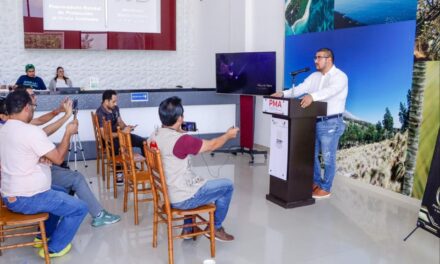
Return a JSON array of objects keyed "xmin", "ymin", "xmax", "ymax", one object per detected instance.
[{"xmin": 96, "ymin": 90, "xmax": 145, "ymax": 156}]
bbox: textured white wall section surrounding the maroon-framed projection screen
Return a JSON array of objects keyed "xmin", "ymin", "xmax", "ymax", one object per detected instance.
[{"xmin": 0, "ymin": 0, "xmax": 200, "ymax": 89}]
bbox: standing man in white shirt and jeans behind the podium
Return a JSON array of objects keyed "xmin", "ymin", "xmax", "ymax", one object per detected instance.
[{"xmin": 272, "ymin": 48, "xmax": 348, "ymax": 199}]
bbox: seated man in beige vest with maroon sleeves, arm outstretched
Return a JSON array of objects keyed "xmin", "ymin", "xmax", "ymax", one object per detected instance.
[{"xmin": 149, "ymin": 96, "xmax": 239, "ymax": 241}]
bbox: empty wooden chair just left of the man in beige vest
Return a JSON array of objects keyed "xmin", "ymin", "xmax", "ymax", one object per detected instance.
[{"xmin": 118, "ymin": 128, "xmax": 153, "ymax": 225}]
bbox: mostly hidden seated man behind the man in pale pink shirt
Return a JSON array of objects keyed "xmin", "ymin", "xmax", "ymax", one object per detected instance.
[{"xmin": 16, "ymin": 88, "xmax": 121, "ymax": 227}]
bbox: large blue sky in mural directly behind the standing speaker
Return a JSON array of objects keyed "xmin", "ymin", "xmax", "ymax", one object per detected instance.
[{"xmin": 284, "ymin": 21, "xmax": 415, "ymax": 127}]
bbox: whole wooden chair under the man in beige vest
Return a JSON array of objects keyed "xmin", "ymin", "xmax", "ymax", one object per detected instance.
[{"xmin": 144, "ymin": 142, "xmax": 215, "ymax": 264}]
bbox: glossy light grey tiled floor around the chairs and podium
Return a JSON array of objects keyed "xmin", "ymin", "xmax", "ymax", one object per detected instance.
[{"xmin": 0, "ymin": 154, "xmax": 440, "ymax": 264}]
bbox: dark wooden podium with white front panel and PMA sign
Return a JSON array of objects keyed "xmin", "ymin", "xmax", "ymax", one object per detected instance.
[{"xmin": 263, "ymin": 96, "xmax": 327, "ymax": 208}]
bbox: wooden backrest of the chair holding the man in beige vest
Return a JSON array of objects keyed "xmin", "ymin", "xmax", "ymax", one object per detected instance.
[{"xmin": 144, "ymin": 142, "xmax": 171, "ymax": 217}]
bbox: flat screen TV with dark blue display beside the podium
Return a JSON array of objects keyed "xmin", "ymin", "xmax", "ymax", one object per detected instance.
[{"xmin": 215, "ymin": 52, "xmax": 276, "ymax": 95}]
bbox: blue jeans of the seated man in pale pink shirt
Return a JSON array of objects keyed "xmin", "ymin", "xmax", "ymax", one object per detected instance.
[{"xmin": 3, "ymin": 190, "xmax": 87, "ymax": 252}]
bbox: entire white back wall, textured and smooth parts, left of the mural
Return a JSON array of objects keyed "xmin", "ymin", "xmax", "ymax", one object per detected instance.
[{"xmin": 0, "ymin": 0, "xmax": 284, "ymax": 146}]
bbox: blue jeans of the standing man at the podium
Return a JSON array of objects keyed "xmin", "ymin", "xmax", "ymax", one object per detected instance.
[{"xmin": 313, "ymin": 117, "xmax": 345, "ymax": 192}]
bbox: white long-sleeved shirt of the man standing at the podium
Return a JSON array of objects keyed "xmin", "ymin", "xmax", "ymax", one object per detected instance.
[{"xmin": 283, "ymin": 65, "xmax": 348, "ymax": 116}]
